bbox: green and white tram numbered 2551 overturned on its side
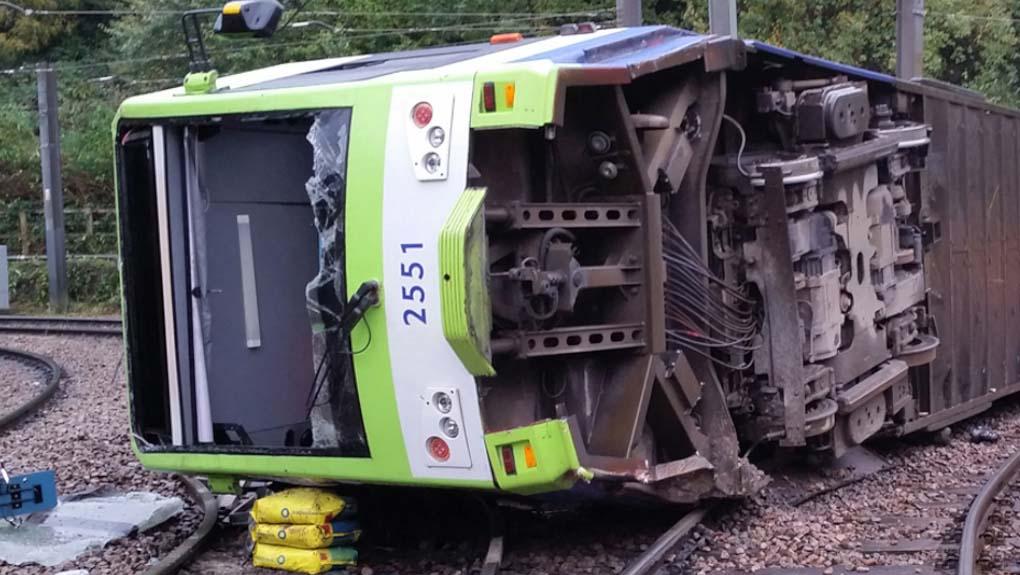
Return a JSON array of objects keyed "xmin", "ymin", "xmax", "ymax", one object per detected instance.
[{"xmin": 114, "ymin": 27, "xmax": 1020, "ymax": 502}]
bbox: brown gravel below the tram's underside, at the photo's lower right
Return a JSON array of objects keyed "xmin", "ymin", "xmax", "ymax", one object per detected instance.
[{"xmin": 684, "ymin": 403, "xmax": 1020, "ymax": 575}]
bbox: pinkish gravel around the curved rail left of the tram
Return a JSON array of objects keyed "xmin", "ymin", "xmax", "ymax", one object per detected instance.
[{"xmin": 0, "ymin": 334, "xmax": 201, "ymax": 575}]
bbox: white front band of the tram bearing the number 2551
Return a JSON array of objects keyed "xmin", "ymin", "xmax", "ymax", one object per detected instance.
[{"xmin": 383, "ymin": 81, "xmax": 493, "ymax": 482}]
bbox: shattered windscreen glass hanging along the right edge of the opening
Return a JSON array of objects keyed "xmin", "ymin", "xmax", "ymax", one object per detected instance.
[{"xmin": 305, "ymin": 109, "xmax": 368, "ymax": 456}]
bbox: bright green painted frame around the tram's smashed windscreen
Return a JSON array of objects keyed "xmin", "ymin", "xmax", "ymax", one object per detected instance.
[{"xmin": 114, "ymin": 83, "xmax": 494, "ymax": 489}]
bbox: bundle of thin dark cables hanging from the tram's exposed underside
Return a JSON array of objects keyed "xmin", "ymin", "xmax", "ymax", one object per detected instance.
[{"xmin": 663, "ymin": 219, "xmax": 761, "ymax": 370}]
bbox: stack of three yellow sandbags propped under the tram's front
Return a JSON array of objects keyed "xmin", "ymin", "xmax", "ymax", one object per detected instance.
[{"xmin": 251, "ymin": 487, "xmax": 361, "ymax": 575}]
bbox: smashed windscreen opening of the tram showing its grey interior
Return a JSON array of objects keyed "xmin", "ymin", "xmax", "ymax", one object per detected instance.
[{"xmin": 118, "ymin": 109, "xmax": 368, "ymax": 457}]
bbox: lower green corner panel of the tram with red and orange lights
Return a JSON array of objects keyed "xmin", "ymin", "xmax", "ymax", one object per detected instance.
[{"xmin": 486, "ymin": 419, "xmax": 588, "ymax": 494}]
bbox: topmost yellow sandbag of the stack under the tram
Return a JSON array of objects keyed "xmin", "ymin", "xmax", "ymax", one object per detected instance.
[{"xmin": 252, "ymin": 487, "xmax": 354, "ymax": 525}]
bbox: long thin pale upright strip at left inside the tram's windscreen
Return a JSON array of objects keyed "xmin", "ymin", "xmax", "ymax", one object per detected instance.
[{"xmin": 152, "ymin": 125, "xmax": 183, "ymax": 446}]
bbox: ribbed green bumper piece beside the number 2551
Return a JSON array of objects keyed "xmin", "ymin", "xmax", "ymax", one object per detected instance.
[{"xmin": 440, "ymin": 188, "xmax": 496, "ymax": 376}]
